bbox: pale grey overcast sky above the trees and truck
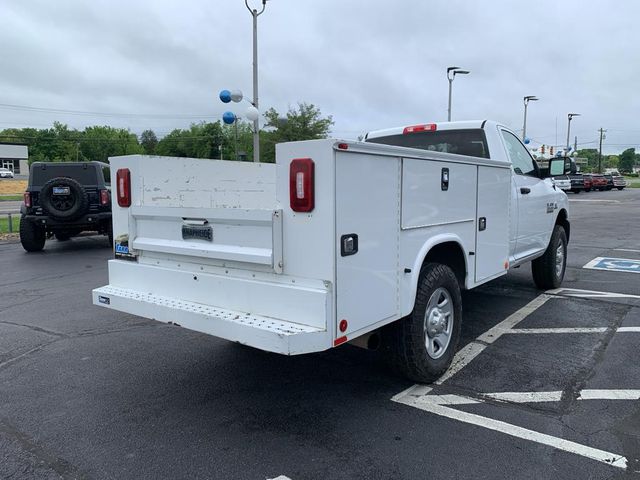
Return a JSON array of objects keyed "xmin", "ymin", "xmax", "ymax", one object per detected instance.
[{"xmin": 0, "ymin": 0, "xmax": 640, "ymax": 153}]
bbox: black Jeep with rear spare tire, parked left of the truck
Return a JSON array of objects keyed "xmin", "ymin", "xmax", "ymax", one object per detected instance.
[{"xmin": 20, "ymin": 162, "xmax": 113, "ymax": 252}]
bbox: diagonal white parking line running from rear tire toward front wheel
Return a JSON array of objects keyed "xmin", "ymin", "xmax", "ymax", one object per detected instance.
[{"xmin": 435, "ymin": 294, "xmax": 552, "ymax": 385}]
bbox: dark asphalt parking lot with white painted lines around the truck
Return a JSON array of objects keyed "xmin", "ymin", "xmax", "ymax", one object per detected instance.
[{"xmin": 0, "ymin": 189, "xmax": 640, "ymax": 480}]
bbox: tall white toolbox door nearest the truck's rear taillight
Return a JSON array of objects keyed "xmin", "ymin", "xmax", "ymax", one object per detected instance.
[{"xmin": 335, "ymin": 152, "xmax": 400, "ymax": 337}]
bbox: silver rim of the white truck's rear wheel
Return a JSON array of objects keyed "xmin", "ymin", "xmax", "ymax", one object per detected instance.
[{"xmin": 424, "ymin": 287, "xmax": 455, "ymax": 360}]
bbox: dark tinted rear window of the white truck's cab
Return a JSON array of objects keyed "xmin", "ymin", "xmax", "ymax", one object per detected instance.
[{"xmin": 366, "ymin": 128, "xmax": 489, "ymax": 158}]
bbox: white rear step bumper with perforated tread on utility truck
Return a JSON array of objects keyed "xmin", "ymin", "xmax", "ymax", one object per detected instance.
[{"xmin": 93, "ymin": 285, "xmax": 332, "ymax": 355}]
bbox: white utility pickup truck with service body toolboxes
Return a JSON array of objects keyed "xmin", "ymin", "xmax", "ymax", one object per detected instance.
[{"xmin": 93, "ymin": 121, "xmax": 569, "ymax": 382}]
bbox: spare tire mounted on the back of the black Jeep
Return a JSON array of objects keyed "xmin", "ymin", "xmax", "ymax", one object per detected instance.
[{"xmin": 39, "ymin": 177, "xmax": 89, "ymax": 221}]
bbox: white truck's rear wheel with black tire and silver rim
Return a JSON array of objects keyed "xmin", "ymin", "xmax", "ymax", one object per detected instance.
[{"xmin": 387, "ymin": 263, "xmax": 462, "ymax": 383}]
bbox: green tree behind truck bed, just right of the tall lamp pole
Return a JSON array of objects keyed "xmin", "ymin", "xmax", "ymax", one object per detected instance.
[{"xmin": 260, "ymin": 102, "xmax": 334, "ymax": 163}]
